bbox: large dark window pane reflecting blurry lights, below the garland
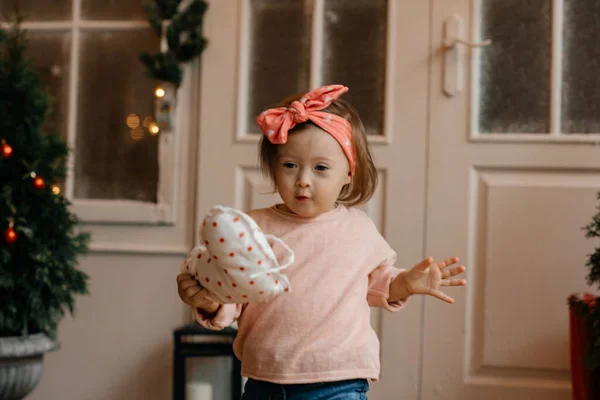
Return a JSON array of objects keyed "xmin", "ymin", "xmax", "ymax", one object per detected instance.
[{"xmin": 75, "ymin": 29, "xmax": 159, "ymax": 202}]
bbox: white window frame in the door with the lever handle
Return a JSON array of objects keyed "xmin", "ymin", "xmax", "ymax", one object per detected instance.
[{"xmin": 469, "ymin": 0, "xmax": 600, "ymax": 144}]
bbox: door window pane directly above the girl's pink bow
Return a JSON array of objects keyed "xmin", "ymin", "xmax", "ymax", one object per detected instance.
[{"xmin": 246, "ymin": 0, "xmax": 313, "ymax": 133}]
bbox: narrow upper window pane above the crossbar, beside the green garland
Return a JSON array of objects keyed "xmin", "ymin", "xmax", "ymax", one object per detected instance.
[{"xmin": 81, "ymin": 0, "xmax": 151, "ymax": 21}]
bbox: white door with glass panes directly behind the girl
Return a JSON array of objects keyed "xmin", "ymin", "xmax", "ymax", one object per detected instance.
[{"xmin": 196, "ymin": 0, "xmax": 430, "ymax": 399}]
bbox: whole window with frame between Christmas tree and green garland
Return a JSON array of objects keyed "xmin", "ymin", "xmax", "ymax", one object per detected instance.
[{"xmin": 0, "ymin": 0, "xmax": 179, "ymax": 224}]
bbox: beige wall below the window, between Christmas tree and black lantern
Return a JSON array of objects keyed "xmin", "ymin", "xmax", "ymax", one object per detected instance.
[{"xmin": 27, "ymin": 254, "xmax": 189, "ymax": 400}]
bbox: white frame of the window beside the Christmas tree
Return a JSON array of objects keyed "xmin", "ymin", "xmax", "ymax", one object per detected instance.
[{"xmin": 3, "ymin": 0, "xmax": 182, "ymax": 225}]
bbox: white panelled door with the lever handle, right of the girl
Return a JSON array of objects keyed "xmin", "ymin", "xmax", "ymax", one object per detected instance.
[{"xmin": 421, "ymin": 0, "xmax": 600, "ymax": 400}]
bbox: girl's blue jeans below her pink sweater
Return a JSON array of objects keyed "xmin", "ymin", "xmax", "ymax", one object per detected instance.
[{"xmin": 242, "ymin": 379, "xmax": 369, "ymax": 400}]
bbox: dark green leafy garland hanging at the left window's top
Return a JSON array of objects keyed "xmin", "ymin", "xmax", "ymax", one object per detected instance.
[{"xmin": 139, "ymin": 0, "xmax": 208, "ymax": 88}]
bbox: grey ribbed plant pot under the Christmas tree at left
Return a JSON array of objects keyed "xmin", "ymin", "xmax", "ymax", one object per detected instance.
[{"xmin": 0, "ymin": 333, "xmax": 57, "ymax": 400}]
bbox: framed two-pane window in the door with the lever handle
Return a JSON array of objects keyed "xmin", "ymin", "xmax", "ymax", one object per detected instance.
[{"xmin": 473, "ymin": 0, "xmax": 600, "ymax": 142}]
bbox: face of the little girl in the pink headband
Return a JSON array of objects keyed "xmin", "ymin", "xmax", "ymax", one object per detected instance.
[{"xmin": 275, "ymin": 125, "xmax": 351, "ymax": 218}]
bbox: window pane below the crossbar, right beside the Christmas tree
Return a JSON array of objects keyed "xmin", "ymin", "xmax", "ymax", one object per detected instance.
[{"xmin": 26, "ymin": 31, "xmax": 71, "ymax": 139}]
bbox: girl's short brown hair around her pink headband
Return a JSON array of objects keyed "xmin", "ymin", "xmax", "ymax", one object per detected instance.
[{"xmin": 259, "ymin": 94, "xmax": 378, "ymax": 207}]
